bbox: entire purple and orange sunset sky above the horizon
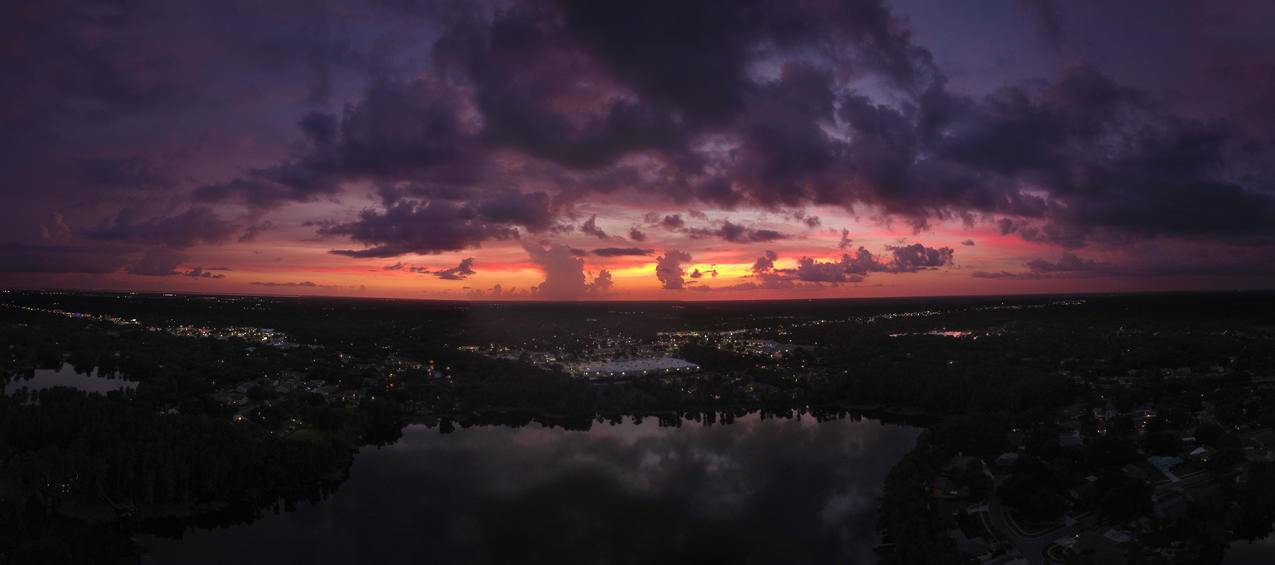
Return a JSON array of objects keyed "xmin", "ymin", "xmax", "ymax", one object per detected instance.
[{"xmin": 0, "ymin": 0, "xmax": 1275, "ymax": 300}]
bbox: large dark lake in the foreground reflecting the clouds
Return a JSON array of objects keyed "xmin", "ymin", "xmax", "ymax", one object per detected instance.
[{"xmin": 143, "ymin": 415, "xmax": 921, "ymax": 564}]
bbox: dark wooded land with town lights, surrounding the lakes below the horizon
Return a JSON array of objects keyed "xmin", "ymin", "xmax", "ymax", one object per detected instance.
[{"xmin": 0, "ymin": 291, "xmax": 1275, "ymax": 564}]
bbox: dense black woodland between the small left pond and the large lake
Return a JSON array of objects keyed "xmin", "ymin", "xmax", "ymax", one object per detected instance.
[{"xmin": 0, "ymin": 388, "xmax": 352, "ymax": 562}]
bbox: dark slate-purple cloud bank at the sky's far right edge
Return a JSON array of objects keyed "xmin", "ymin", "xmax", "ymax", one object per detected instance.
[{"xmin": 932, "ymin": 66, "xmax": 1275, "ymax": 241}]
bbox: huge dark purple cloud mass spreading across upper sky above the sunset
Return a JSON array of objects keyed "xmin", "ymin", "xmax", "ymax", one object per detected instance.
[{"xmin": 219, "ymin": 1, "xmax": 1244, "ymax": 258}]
